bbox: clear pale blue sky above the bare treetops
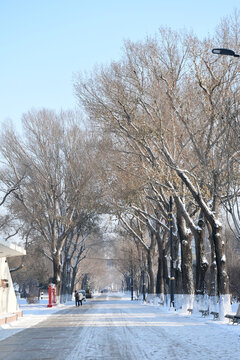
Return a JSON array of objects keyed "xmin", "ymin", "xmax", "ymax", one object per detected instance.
[{"xmin": 0, "ymin": 0, "xmax": 240, "ymax": 129}]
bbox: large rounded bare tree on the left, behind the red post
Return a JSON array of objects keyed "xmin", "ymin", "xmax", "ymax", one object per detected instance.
[{"xmin": 1, "ymin": 110, "xmax": 101, "ymax": 295}]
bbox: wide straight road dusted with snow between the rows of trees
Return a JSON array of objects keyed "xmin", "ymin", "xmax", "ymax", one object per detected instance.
[{"xmin": 0, "ymin": 296, "xmax": 240, "ymax": 360}]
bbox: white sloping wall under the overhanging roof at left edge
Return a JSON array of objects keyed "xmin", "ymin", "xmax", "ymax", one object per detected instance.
[{"xmin": 0, "ymin": 257, "xmax": 19, "ymax": 315}]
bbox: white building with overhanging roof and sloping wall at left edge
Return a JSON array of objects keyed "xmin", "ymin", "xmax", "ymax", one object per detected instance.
[{"xmin": 0, "ymin": 240, "xmax": 26, "ymax": 325}]
